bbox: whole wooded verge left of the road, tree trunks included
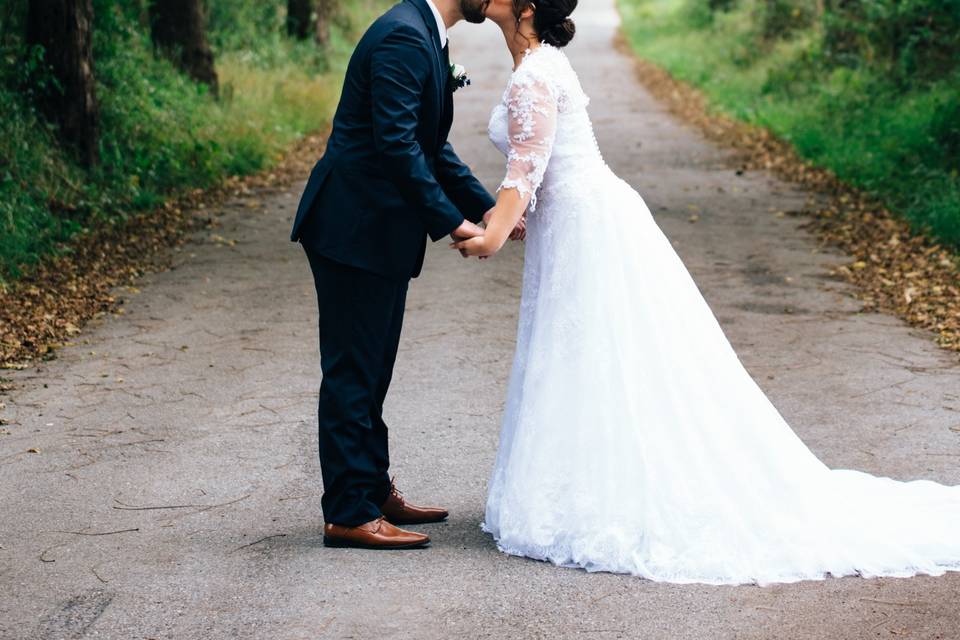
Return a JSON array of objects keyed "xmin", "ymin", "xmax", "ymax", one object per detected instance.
[{"xmin": 0, "ymin": 0, "xmax": 388, "ymax": 287}]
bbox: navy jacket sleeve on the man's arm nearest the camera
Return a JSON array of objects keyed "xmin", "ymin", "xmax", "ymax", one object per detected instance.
[{"xmin": 371, "ymin": 27, "xmax": 464, "ymax": 241}]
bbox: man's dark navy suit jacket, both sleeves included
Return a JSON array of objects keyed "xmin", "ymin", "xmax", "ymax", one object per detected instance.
[{"xmin": 290, "ymin": 0, "xmax": 494, "ymax": 281}]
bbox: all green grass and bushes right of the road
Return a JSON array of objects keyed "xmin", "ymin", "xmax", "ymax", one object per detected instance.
[{"xmin": 620, "ymin": 0, "xmax": 960, "ymax": 247}]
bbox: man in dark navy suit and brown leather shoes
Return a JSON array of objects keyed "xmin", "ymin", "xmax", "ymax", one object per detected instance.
[{"xmin": 291, "ymin": 0, "xmax": 495, "ymax": 549}]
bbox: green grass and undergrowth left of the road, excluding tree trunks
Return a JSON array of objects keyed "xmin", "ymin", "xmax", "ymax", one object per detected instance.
[{"xmin": 0, "ymin": 0, "xmax": 387, "ymax": 285}]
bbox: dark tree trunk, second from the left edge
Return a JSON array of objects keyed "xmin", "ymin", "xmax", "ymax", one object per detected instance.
[{"xmin": 150, "ymin": 0, "xmax": 218, "ymax": 95}]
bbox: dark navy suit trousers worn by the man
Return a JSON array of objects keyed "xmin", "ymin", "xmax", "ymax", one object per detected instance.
[{"xmin": 304, "ymin": 247, "xmax": 408, "ymax": 527}]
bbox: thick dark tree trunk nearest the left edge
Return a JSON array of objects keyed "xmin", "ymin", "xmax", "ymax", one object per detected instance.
[{"xmin": 27, "ymin": 0, "xmax": 100, "ymax": 167}]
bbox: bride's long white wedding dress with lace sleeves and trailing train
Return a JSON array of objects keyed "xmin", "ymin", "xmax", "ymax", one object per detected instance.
[{"xmin": 482, "ymin": 45, "xmax": 960, "ymax": 585}]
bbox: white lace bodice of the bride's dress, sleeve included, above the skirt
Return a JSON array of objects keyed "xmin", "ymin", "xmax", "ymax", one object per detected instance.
[{"xmin": 489, "ymin": 44, "xmax": 603, "ymax": 211}]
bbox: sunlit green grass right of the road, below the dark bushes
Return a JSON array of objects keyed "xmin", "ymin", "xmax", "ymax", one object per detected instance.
[{"xmin": 619, "ymin": 0, "xmax": 960, "ymax": 249}]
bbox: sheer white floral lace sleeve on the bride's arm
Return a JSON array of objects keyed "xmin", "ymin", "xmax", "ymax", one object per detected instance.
[{"xmin": 497, "ymin": 77, "xmax": 557, "ymax": 211}]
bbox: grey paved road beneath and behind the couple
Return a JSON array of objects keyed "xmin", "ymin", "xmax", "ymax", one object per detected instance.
[{"xmin": 0, "ymin": 0, "xmax": 960, "ymax": 640}]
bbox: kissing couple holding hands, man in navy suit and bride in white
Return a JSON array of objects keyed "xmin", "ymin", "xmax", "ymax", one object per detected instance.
[{"xmin": 291, "ymin": 0, "xmax": 960, "ymax": 584}]
